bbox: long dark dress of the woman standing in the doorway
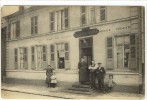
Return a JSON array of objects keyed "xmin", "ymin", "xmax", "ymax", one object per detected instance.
[{"xmin": 78, "ymin": 62, "xmax": 89, "ymax": 82}]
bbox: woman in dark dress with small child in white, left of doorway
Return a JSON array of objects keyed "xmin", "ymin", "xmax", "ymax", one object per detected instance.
[{"xmin": 46, "ymin": 65, "xmax": 57, "ymax": 88}]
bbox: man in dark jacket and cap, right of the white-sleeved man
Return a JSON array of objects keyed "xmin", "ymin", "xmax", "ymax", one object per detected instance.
[{"xmin": 96, "ymin": 63, "xmax": 106, "ymax": 93}]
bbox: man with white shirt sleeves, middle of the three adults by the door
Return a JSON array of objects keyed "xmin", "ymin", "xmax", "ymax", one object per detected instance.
[{"xmin": 89, "ymin": 60, "xmax": 98, "ymax": 89}]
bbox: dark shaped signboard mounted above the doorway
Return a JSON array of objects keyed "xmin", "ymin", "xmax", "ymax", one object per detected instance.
[{"xmin": 74, "ymin": 27, "xmax": 99, "ymax": 38}]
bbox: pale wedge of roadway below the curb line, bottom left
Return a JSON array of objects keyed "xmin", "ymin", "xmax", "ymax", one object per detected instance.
[{"xmin": 1, "ymin": 90, "xmax": 58, "ymax": 99}]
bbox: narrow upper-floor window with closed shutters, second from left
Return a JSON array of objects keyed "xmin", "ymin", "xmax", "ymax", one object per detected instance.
[{"xmin": 31, "ymin": 16, "xmax": 38, "ymax": 35}]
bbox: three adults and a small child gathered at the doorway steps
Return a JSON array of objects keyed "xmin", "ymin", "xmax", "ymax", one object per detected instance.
[{"xmin": 78, "ymin": 58, "xmax": 115, "ymax": 93}]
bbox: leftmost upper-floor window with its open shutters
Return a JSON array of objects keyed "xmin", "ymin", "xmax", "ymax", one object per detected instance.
[{"xmin": 8, "ymin": 21, "xmax": 20, "ymax": 39}]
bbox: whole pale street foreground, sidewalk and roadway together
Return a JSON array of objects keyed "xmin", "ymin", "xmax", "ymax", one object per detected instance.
[{"xmin": 2, "ymin": 83, "xmax": 144, "ymax": 100}]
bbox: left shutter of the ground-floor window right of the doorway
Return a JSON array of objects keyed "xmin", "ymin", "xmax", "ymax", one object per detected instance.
[{"xmin": 106, "ymin": 37, "xmax": 113, "ymax": 69}]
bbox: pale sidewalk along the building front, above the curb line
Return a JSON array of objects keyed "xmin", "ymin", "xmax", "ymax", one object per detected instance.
[{"xmin": 1, "ymin": 83, "xmax": 144, "ymax": 100}]
